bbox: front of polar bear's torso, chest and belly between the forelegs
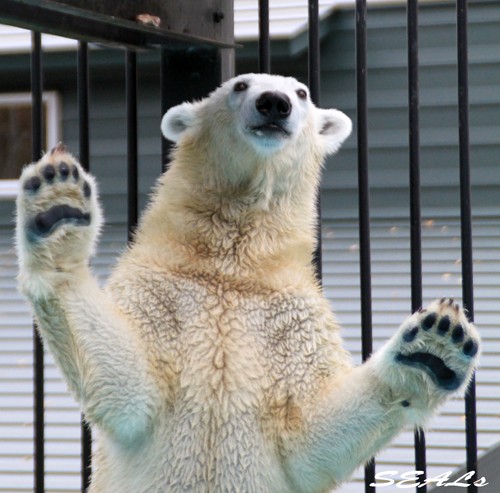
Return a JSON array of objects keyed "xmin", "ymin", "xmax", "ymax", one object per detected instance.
[{"xmin": 103, "ymin": 272, "xmax": 328, "ymax": 493}]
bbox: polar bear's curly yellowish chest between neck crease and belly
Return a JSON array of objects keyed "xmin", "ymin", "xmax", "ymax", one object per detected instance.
[{"xmin": 112, "ymin": 273, "xmax": 334, "ymax": 413}]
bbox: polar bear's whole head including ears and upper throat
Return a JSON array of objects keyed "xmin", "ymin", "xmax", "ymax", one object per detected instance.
[{"xmin": 161, "ymin": 74, "xmax": 352, "ymax": 204}]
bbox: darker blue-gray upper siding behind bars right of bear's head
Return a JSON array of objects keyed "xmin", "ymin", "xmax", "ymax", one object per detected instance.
[{"xmin": 243, "ymin": 1, "xmax": 500, "ymax": 217}]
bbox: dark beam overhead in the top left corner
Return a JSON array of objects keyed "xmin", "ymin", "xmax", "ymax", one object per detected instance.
[{"xmin": 0, "ymin": 0, "xmax": 234, "ymax": 48}]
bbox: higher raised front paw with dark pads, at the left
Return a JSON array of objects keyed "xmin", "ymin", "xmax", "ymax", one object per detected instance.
[{"xmin": 17, "ymin": 144, "xmax": 101, "ymax": 267}]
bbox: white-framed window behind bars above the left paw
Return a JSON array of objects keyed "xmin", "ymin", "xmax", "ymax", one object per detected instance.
[{"xmin": 0, "ymin": 92, "xmax": 61, "ymax": 199}]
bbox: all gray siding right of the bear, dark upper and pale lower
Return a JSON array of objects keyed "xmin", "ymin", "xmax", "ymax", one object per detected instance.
[{"xmin": 310, "ymin": 2, "xmax": 500, "ymax": 493}]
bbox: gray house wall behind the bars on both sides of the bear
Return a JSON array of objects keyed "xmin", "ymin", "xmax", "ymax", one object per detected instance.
[{"xmin": 0, "ymin": 1, "xmax": 500, "ymax": 493}]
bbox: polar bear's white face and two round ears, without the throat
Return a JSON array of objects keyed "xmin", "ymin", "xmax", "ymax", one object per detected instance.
[{"xmin": 161, "ymin": 74, "xmax": 351, "ymax": 155}]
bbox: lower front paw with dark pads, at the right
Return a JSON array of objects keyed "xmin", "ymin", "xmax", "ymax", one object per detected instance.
[{"xmin": 393, "ymin": 298, "xmax": 479, "ymax": 391}]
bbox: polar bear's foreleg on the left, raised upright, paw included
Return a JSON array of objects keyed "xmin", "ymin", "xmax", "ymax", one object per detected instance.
[{"xmin": 16, "ymin": 146, "xmax": 157, "ymax": 443}]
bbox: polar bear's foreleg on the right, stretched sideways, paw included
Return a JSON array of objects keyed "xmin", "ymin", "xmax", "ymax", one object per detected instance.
[{"xmin": 287, "ymin": 299, "xmax": 479, "ymax": 493}]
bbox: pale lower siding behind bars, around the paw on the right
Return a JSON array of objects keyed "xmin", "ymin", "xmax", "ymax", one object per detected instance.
[{"xmin": 323, "ymin": 216, "xmax": 500, "ymax": 493}]
